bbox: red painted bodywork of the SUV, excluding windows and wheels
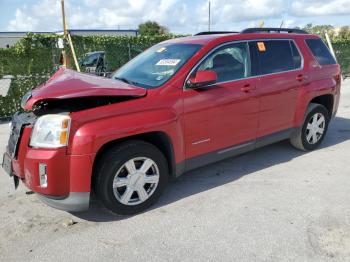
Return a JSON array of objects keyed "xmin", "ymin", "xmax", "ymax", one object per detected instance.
[{"xmin": 13, "ymin": 33, "xmax": 340, "ymax": 199}]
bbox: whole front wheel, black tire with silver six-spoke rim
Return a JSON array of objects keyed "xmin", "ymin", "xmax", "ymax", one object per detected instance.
[{"xmin": 93, "ymin": 140, "xmax": 169, "ymax": 215}]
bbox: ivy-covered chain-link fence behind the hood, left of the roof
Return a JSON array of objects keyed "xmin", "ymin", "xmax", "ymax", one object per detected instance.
[{"xmin": 0, "ymin": 35, "xmax": 175, "ymax": 121}]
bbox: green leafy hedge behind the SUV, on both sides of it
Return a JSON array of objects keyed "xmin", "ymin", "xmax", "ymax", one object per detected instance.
[{"xmin": 0, "ymin": 34, "xmax": 350, "ymax": 118}]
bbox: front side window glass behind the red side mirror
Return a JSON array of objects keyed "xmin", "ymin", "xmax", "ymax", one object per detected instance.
[{"xmin": 197, "ymin": 42, "xmax": 250, "ymax": 82}]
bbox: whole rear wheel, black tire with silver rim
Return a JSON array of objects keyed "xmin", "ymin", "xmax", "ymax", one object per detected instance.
[{"xmin": 290, "ymin": 103, "xmax": 330, "ymax": 151}]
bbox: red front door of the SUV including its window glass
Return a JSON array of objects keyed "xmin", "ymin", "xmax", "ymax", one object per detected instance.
[{"xmin": 184, "ymin": 42, "xmax": 259, "ymax": 166}]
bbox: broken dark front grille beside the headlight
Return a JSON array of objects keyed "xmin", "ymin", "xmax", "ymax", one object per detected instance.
[{"xmin": 8, "ymin": 113, "xmax": 36, "ymax": 158}]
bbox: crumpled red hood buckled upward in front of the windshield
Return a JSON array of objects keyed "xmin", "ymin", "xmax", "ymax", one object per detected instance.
[{"xmin": 22, "ymin": 68, "xmax": 147, "ymax": 110}]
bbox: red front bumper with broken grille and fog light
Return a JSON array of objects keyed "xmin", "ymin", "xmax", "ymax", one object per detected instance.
[{"xmin": 2, "ymin": 111, "xmax": 93, "ymax": 212}]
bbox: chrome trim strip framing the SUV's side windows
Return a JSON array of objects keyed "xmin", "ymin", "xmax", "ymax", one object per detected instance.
[{"xmin": 182, "ymin": 38, "xmax": 304, "ymax": 91}]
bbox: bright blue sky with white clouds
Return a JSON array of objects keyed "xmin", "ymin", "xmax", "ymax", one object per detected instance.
[{"xmin": 0, "ymin": 0, "xmax": 350, "ymax": 34}]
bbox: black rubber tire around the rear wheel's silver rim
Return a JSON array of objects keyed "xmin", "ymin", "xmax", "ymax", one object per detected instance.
[{"xmin": 290, "ymin": 103, "xmax": 330, "ymax": 151}]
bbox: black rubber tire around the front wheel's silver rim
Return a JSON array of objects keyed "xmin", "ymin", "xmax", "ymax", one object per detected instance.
[{"xmin": 93, "ymin": 140, "xmax": 169, "ymax": 215}]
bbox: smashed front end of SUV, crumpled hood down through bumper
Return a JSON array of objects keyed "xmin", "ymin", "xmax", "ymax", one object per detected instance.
[{"xmin": 2, "ymin": 67, "xmax": 146, "ymax": 211}]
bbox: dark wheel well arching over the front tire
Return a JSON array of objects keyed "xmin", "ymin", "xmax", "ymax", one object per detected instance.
[{"xmin": 91, "ymin": 132, "xmax": 175, "ymax": 183}]
